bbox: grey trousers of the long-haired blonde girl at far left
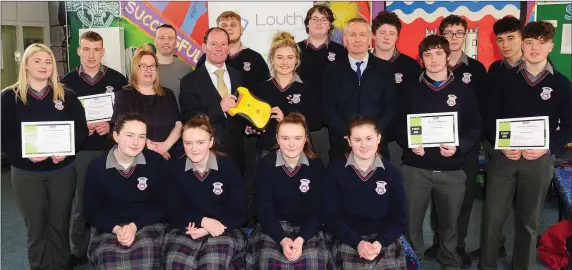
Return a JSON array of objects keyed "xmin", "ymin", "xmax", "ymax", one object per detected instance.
[{"xmin": 10, "ymin": 164, "xmax": 76, "ymax": 270}]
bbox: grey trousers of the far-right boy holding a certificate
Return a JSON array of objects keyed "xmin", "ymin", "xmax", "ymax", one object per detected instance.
[{"xmin": 479, "ymin": 151, "xmax": 554, "ymax": 270}]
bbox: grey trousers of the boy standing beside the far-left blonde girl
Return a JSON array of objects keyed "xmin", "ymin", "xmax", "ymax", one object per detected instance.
[{"xmin": 70, "ymin": 150, "xmax": 104, "ymax": 257}]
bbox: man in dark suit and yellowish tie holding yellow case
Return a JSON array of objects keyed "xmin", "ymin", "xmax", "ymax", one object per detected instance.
[{"xmin": 179, "ymin": 27, "xmax": 246, "ymax": 173}]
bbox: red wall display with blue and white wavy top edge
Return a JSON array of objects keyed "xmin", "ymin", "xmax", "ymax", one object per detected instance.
[{"xmin": 386, "ymin": 1, "xmax": 520, "ymax": 69}]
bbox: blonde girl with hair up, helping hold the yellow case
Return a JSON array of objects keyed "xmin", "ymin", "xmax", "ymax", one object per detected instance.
[{"xmin": 247, "ymin": 32, "xmax": 322, "ymax": 156}]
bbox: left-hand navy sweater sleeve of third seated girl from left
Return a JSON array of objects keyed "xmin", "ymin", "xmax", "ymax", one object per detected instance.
[{"xmin": 254, "ymin": 159, "xmax": 286, "ymax": 244}]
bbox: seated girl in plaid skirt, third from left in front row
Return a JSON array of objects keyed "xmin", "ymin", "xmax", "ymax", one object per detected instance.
[{"xmin": 248, "ymin": 113, "xmax": 329, "ymax": 269}]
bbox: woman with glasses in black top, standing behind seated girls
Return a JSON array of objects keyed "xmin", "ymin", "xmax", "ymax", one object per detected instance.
[{"xmin": 111, "ymin": 48, "xmax": 183, "ymax": 160}]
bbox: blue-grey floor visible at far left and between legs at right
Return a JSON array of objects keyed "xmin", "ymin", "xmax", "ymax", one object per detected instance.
[{"xmin": 1, "ymin": 170, "xmax": 558, "ymax": 270}]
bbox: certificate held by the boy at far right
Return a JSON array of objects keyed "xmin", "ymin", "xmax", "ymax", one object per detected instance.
[{"xmin": 495, "ymin": 116, "xmax": 550, "ymax": 150}]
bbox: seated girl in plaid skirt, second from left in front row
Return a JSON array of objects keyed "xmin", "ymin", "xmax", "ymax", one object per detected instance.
[{"xmin": 163, "ymin": 115, "xmax": 247, "ymax": 270}]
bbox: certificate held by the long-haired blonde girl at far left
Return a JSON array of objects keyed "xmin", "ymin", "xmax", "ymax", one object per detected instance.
[{"xmin": 22, "ymin": 121, "xmax": 75, "ymax": 158}]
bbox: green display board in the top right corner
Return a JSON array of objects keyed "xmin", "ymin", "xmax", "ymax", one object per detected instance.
[{"xmin": 536, "ymin": 3, "xmax": 572, "ymax": 80}]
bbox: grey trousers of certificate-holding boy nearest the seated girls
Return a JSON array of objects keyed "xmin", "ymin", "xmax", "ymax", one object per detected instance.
[{"xmin": 403, "ymin": 165, "xmax": 467, "ymax": 269}]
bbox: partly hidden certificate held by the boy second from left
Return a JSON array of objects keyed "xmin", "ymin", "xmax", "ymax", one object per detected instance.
[{"xmin": 78, "ymin": 93, "xmax": 115, "ymax": 123}]
